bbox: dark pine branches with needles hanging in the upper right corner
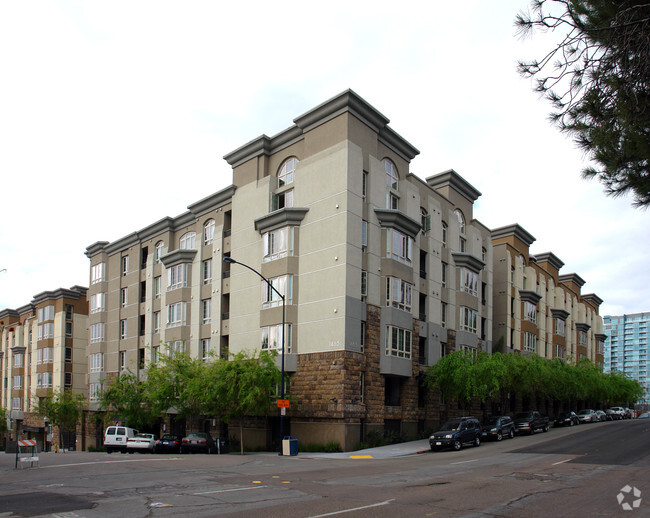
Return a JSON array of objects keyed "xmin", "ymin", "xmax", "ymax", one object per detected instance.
[{"xmin": 515, "ymin": 0, "xmax": 650, "ymax": 207}]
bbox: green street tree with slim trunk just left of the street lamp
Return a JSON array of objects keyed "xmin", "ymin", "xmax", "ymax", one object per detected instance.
[{"xmin": 208, "ymin": 351, "xmax": 280, "ymax": 455}]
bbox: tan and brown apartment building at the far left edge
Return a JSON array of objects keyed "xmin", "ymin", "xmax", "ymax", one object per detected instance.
[{"xmin": 0, "ymin": 286, "xmax": 88, "ymax": 445}]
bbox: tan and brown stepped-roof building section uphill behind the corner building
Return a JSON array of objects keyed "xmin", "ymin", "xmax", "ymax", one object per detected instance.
[{"xmin": 492, "ymin": 224, "xmax": 606, "ymax": 368}]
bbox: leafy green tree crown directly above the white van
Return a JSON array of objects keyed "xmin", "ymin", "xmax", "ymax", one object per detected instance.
[{"xmin": 100, "ymin": 370, "xmax": 159, "ymax": 429}]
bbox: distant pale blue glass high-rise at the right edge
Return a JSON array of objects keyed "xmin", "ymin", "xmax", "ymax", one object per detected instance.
[{"xmin": 603, "ymin": 312, "xmax": 650, "ymax": 408}]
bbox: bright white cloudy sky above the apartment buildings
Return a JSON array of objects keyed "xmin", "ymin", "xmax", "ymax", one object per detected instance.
[{"xmin": 0, "ymin": 0, "xmax": 650, "ymax": 314}]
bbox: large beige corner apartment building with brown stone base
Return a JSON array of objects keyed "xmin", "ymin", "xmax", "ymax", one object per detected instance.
[{"xmin": 86, "ymin": 90, "xmax": 492, "ymax": 449}]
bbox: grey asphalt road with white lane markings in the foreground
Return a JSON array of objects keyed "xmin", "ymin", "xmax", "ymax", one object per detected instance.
[{"xmin": 0, "ymin": 420, "xmax": 650, "ymax": 518}]
